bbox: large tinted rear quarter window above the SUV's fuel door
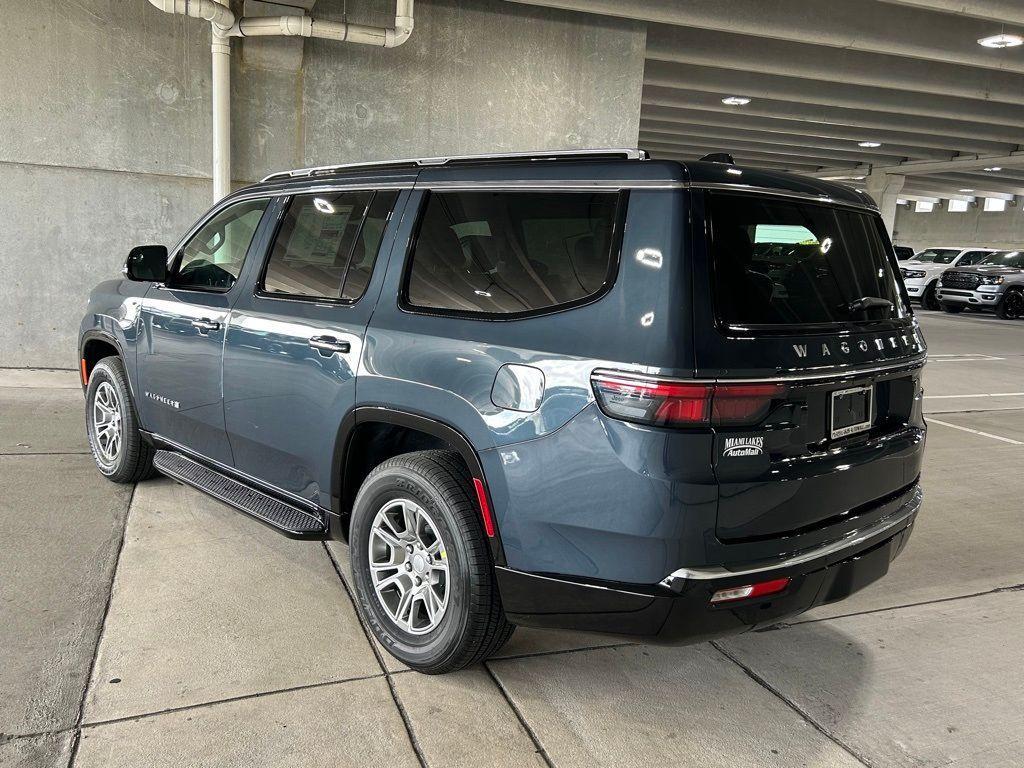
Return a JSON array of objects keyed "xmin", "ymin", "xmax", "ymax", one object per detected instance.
[{"xmin": 407, "ymin": 191, "xmax": 618, "ymax": 314}]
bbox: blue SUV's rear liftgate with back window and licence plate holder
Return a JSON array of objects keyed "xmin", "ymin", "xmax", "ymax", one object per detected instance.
[{"xmin": 694, "ymin": 191, "xmax": 925, "ymax": 548}]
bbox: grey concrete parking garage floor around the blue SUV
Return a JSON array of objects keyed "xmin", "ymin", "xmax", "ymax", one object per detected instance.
[{"xmin": 0, "ymin": 312, "xmax": 1024, "ymax": 768}]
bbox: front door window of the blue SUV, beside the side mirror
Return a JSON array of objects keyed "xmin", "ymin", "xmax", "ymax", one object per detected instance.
[{"xmin": 171, "ymin": 200, "xmax": 269, "ymax": 291}]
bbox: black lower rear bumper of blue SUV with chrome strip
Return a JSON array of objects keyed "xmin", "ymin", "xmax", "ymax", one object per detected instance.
[{"xmin": 497, "ymin": 492, "xmax": 922, "ymax": 643}]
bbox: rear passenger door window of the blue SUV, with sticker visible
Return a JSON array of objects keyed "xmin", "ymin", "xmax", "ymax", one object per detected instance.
[{"xmin": 263, "ymin": 191, "xmax": 397, "ymax": 301}]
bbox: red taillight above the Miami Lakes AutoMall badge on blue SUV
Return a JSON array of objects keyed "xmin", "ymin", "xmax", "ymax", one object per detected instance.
[{"xmin": 591, "ymin": 372, "xmax": 786, "ymax": 427}]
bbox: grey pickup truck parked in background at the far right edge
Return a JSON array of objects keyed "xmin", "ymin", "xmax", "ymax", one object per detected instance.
[{"xmin": 936, "ymin": 251, "xmax": 1024, "ymax": 319}]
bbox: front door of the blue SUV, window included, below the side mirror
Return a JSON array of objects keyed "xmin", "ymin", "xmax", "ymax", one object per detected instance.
[{"xmin": 136, "ymin": 199, "xmax": 269, "ymax": 465}]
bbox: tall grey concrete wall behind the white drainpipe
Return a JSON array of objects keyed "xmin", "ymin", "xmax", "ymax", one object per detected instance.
[{"xmin": 0, "ymin": 0, "xmax": 645, "ymax": 368}]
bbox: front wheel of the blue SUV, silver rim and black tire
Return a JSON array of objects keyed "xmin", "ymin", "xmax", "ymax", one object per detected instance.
[{"xmin": 85, "ymin": 356, "xmax": 156, "ymax": 483}]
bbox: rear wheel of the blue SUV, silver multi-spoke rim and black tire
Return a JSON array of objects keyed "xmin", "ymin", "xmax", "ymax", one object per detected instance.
[{"xmin": 349, "ymin": 451, "xmax": 515, "ymax": 675}]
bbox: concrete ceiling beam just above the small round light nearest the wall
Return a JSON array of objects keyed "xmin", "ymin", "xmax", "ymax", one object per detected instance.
[{"xmin": 644, "ymin": 61, "xmax": 1024, "ymax": 129}]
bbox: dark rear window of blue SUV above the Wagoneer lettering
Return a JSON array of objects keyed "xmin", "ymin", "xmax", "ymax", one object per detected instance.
[{"xmin": 708, "ymin": 193, "xmax": 908, "ymax": 327}]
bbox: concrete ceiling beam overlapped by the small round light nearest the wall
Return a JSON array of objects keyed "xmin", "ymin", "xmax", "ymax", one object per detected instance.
[{"xmin": 642, "ymin": 86, "xmax": 1024, "ymax": 146}]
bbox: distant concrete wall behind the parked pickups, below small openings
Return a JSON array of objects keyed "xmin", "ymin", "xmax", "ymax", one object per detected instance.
[{"xmin": 893, "ymin": 199, "xmax": 1024, "ymax": 249}]
